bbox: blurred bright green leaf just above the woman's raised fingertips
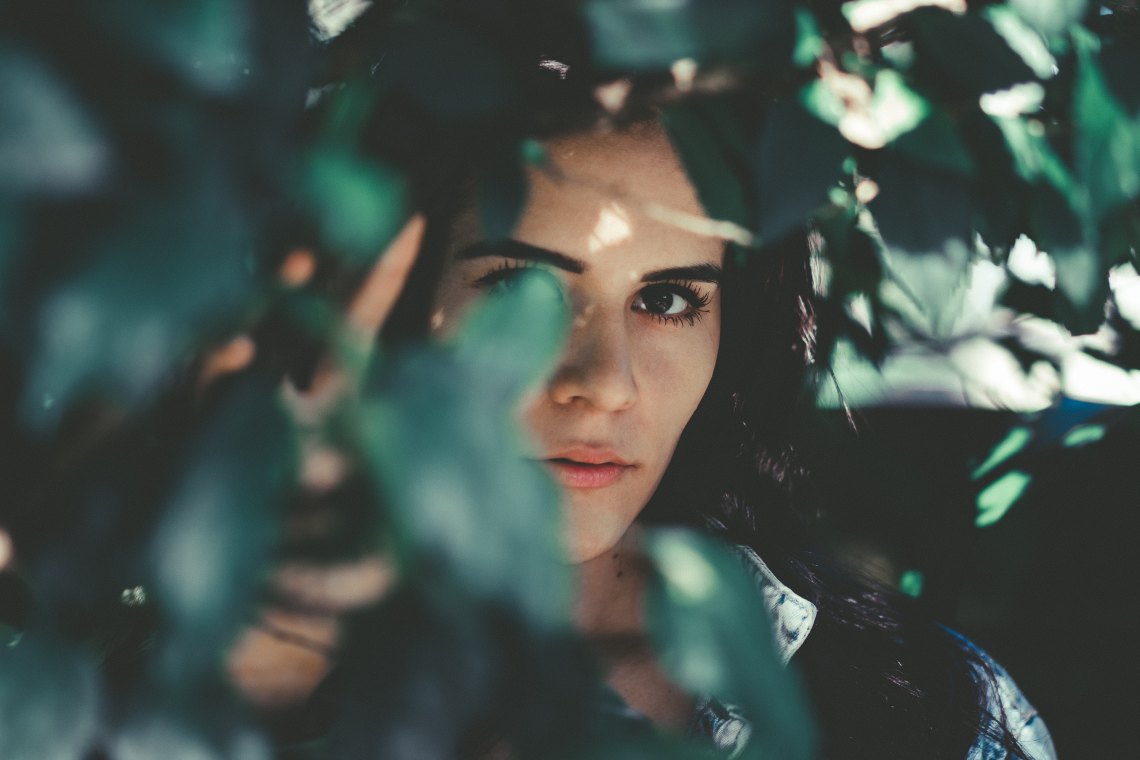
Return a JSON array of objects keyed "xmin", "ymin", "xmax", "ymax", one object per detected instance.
[{"xmin": 302, "ymin": 149, "xmax": 407, "ymax": 264}]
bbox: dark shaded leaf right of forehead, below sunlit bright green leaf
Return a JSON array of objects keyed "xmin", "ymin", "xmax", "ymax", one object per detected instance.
[{"xmin": 754, "ymin": 101, "xmax": 853, "ymax": 242}]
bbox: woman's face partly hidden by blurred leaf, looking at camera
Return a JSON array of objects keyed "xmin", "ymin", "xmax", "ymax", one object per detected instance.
[{"xmin": 432, "ymin": 129, "xmax": 724, "ymax": 563}]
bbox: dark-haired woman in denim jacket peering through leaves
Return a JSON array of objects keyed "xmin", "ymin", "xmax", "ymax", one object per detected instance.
[{"xmin": 369, "ymin": 121, "xmax": 1053, "ymax": 758}]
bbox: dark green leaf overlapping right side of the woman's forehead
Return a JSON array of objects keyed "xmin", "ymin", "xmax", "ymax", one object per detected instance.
[{"xmin": 661, "ymin": 103, "xmax": 749, "ymax": 226}]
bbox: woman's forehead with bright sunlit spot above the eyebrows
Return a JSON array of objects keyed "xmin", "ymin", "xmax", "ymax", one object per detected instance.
[{"xmin": 513, "ymin": 126, "xmax": 724, "ymax": 269}]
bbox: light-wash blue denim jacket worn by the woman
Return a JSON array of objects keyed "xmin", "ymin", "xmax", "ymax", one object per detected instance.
[{"xmin": 674, "ymin": 546, "xmax": 1057, "ymax": 760}]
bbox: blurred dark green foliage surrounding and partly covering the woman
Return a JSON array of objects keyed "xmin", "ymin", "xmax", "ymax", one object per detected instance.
[{"xmin": 0, "ymin": 0, "xmax": 1140, "ymax": 759}]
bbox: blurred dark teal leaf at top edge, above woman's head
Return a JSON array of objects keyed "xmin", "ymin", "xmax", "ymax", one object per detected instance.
[{"xmin": 583, "ymin": 0, "xmax": 797, "ymax": 70}]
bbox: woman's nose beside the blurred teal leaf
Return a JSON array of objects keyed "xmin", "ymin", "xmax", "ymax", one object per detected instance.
[{"xmin": 547, "ymin": 308, "xmax": 637, "ymax": 411}]
